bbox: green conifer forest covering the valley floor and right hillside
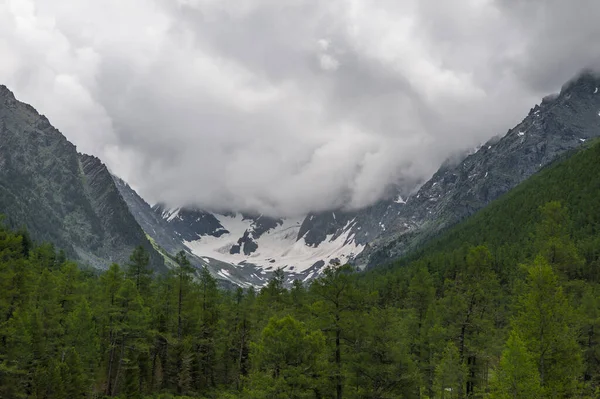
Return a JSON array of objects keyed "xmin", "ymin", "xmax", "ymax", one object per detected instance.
[{"xmin": 0, "ymin": 144, "xmax": 600, "ymax": 399}]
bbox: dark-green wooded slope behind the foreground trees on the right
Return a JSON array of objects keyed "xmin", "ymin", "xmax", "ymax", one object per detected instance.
[{"xmin": 390, "ymin": 139, "xmax": 600, "ymax": 281}]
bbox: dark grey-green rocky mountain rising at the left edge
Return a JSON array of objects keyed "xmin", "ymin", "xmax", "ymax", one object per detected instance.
[{"xmin": 0, "ymin": 85, "xmax": 164, "ymax": 270}]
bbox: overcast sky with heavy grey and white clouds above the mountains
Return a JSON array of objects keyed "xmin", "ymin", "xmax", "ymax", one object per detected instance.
[{"xmin": 0, "ymin": 0, "xmax": 600, "ymax": 216}]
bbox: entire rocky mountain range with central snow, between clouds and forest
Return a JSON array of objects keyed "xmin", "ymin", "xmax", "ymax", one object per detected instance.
[{"xmin": 0, "ymin": 72, "xmax": 600, "ymax": 286}]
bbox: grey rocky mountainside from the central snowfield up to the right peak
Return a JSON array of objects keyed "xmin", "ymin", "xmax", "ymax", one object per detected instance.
[{"xmin": 115, "ymin": 73, "xmax": 600, "ymax": 285}]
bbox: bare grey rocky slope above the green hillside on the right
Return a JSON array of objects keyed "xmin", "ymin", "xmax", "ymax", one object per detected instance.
[{"xmin": 355, "ymin": 73, "xmax": 600, "ymax": 267}]
